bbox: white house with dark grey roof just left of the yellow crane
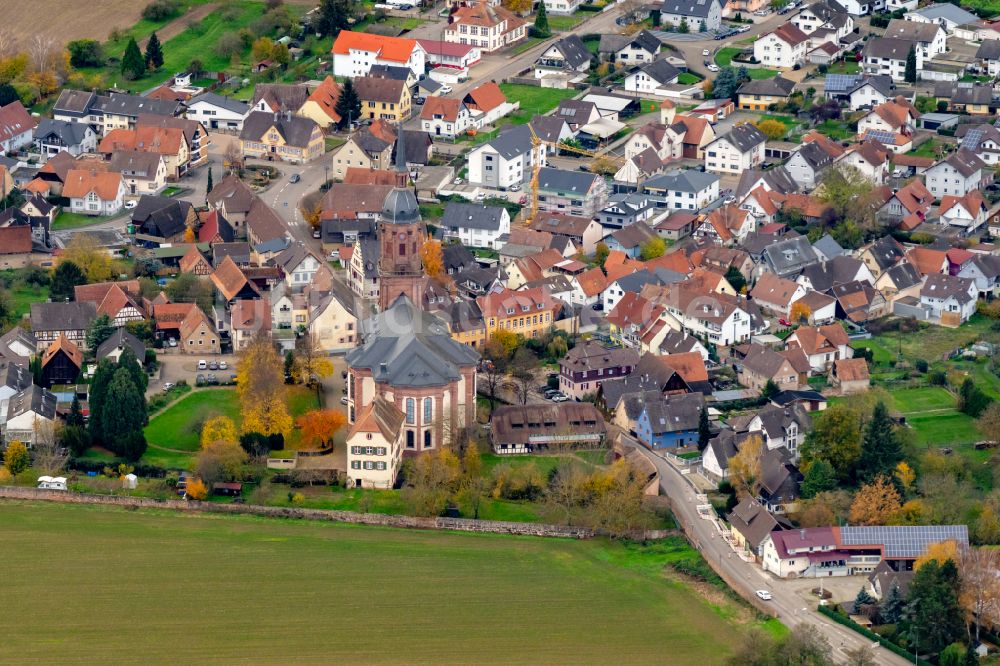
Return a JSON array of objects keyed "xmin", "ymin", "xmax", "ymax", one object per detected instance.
[{"xmin": 466, "ymin": 125, "xmax": 544, "ymax": 189}]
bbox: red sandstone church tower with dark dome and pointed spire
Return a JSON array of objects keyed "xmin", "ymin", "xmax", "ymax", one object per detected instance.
[{"xmin": 378, "ymin": 125, "xmax": 427, "ymax": 312}]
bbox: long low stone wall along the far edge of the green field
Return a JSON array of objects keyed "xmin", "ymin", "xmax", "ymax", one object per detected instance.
[{"xmin": 0, "ymin": 486, "xmax": 680, "ymax": 540}]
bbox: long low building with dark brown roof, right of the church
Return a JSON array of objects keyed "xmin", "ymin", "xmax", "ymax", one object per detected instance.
[{"xmin": 490, "ymin": 402, "xmax": 607, "ymax": 455}]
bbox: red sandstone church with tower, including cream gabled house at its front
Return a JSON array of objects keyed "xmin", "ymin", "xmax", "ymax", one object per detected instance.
[{"xmin": 347, "ymin": 127, "xmax": 479, "ymax": 487}]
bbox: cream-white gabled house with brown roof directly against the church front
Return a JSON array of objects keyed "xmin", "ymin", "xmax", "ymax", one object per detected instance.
[{"xmin": 347, "ymin": 395, "xmax": 405, "ymax": 489}]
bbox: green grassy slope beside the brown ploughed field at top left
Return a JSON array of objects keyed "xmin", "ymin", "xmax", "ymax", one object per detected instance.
[{"xmin": 83, "ymin": 0, "xmax": 274, "ymax": 92}]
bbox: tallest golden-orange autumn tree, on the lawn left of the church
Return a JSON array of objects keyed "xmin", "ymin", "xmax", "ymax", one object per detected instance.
[{"xmin": 236, "ymin": 335, "xmax": 292, "ymax": 436}]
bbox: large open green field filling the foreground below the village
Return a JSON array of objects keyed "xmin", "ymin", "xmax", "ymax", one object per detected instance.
[{"xmin": 0, "ymin": 502, "xmax": 740, "ymax": 666}]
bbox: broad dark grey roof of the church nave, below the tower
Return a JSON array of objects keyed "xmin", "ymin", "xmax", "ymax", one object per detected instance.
[{"xmin": 347, "ymin": 296, "xmax": 479, "ymax": 388}]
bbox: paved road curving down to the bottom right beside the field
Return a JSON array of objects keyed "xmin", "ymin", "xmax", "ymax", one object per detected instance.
[{"xmin": 623, "ymin": 436, "xmax": 909, "ymax": 666}]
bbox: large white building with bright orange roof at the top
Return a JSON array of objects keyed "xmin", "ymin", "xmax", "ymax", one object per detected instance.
[{"xmin": 333, "ymin": 30, "xmax": 422, "ymax": 79}]
